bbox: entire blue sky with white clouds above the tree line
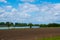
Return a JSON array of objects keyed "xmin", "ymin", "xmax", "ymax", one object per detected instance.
[{"xmin": 0, "ymin": 0, "xmax": 60, "ymax": 24}]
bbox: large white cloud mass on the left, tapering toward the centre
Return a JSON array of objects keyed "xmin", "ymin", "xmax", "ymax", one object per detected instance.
[{"xmin": 0, "ymin": 6, "xmax": 30, "ymax": 22}]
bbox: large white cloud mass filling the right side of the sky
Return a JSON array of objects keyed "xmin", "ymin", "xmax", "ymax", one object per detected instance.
[{"xmin": 32, "ymin": 3, "xmax": 60, "ymax": 23}]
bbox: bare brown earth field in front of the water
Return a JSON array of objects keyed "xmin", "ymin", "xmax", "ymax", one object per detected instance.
[{"xmin": 0, "ymin": 28, "xmax": 60, "ymax": 40}]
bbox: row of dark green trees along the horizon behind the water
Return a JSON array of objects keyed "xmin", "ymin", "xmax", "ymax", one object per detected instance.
[{"xmin": 0, "ymin": 22, "xmax": 60, "ymax": 28}]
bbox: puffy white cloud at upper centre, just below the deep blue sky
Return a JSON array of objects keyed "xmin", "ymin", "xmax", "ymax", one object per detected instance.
[{"xmin": 19, "ymin": 3, "xmax": 39, "ymax": 13}]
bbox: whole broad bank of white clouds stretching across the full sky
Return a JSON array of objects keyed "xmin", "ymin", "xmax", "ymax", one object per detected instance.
[{"xmin": 0, "ymin": 3, "xmax": 60, "ymax": 23}]
